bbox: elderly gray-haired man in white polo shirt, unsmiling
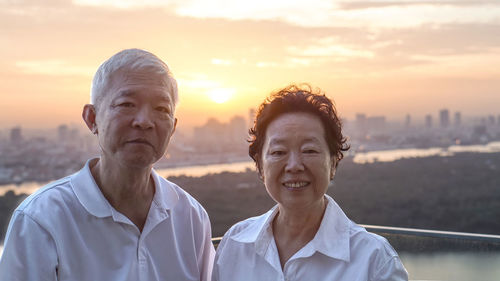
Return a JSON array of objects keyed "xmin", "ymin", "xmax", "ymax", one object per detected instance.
[{"xmin": 0, "ymin": 49, "xmax": 214, "ymax": 281}]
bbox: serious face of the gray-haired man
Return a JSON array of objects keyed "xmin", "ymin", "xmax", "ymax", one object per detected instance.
[{"xmin": 95, "ymin": 71, "xmax": 177, "ymax": 168}]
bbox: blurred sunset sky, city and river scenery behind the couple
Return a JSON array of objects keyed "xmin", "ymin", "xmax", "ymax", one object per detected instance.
[{"xmin": 0, "ymin": 0, "xmax": 500, "ymax": 280}]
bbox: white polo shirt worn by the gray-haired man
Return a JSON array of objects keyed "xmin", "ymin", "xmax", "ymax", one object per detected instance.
[{"xmin": 0, "ymin": 160, "xmax": 215, "ymax": 281}]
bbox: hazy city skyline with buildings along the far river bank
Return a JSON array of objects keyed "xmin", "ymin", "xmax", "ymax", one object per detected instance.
[{"xmin": 0, "ymin": 109, "xmax": 500, "ymax": 184}]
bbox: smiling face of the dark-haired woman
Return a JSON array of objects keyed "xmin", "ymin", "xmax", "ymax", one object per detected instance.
[{"xmin": 260, "ymin": 112, "xmax": 335, "ymax": 210}]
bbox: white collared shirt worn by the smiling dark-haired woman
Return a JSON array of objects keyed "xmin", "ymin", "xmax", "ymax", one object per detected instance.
[{"xmin": 212, "ymin": 195, "xmax": 408, "ymax": 281}]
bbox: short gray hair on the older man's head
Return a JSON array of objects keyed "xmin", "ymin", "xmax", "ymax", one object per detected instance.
[{"xmin": 90, "ymin": 49, "xmax": 178, "ymax": 107}]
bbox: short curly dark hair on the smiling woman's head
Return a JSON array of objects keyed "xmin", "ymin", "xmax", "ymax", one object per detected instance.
[{"xmin": 248, "ymin": 84, "xmax": 349, "ymax": 172}]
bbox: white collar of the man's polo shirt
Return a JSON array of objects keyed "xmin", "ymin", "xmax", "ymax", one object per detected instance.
[{"xmin": 71, "ymin": 158, "xmax": 179, "ymax": 218}]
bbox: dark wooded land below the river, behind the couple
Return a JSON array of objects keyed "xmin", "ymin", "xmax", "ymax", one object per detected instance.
[{"xmin": 0, "ymin": 153, "xmax": 500, "ymax": 240}]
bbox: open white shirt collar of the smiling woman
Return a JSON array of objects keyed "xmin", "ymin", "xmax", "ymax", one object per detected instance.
[{"xmin": 231, "ymin": 194, "xmax": 351, "ymax": 261}]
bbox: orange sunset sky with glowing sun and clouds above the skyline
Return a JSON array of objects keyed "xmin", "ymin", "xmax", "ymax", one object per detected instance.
[{"xmin": 0, "ymin": 0, "xmax": 500, "ymax": 128}]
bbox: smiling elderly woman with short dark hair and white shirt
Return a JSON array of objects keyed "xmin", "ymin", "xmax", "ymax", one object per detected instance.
[{"xmin": 213, "ymin": 86, "xmax": 408, "ymax": 281}]
